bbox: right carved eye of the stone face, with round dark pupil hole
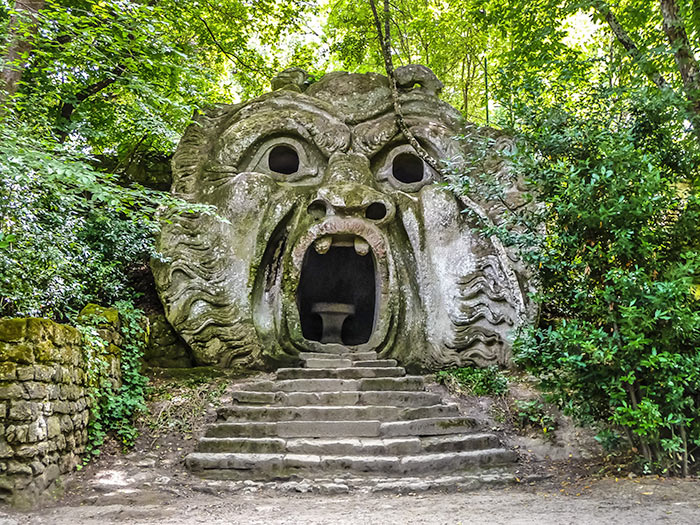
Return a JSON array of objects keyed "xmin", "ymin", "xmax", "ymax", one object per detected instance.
[{"xmin": 373, "ymin": 144, "xmax": 434, "ymax": 192}]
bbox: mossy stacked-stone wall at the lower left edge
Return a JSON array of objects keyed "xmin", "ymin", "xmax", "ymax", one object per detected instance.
[{"xmin": 0, "ymin": 318, "xmax": 119, "ymax": 506}]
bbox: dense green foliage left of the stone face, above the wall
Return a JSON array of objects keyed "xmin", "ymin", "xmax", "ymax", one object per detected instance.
[{"xmin": 0, "ymin": 0, "xmax": 312, "ymax": 320}]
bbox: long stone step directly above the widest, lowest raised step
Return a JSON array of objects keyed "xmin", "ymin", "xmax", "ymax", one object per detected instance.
[{"xmin": 197, "ymin": 433, "xmax": 499, "ymax": 456}]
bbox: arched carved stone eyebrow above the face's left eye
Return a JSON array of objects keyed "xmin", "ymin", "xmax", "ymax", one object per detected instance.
[{"xmin": 214, "ymin": 95, "xmax": 350, "ymax": 168}]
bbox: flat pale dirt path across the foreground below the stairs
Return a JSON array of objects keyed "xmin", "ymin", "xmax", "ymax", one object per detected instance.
[{"xmin": 0, "ymin": 478, "xmax": 700, "ymax": 525}]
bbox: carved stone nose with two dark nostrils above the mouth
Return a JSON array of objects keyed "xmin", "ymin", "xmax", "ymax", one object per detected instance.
[{"xmin": 307, "ymin": 154, "xmax": 395, "ymax": 223}]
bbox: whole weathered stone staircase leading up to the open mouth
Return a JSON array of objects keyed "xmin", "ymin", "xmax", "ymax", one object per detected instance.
[{"xmin": 185, "ymin": 347, "xmax": 516, "ymax": 480}]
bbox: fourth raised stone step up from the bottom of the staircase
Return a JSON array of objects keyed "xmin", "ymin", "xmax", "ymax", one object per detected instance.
[{"xmin": 217, "ymin": 404, "xmax": 459, "ymax": 422}]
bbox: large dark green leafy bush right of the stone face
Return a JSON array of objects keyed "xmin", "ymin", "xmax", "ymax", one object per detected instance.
[{"xmin": 470, "ymin": 87, "xmax": 700, "ymax": 473}]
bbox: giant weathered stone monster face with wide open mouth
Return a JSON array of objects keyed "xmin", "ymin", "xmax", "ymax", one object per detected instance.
[{"xmin": 153, "ymin": 66, "xmax": 532, "ymax": 369}]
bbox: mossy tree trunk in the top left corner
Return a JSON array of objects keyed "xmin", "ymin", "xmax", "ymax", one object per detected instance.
[{"xmin": 0, "ymin": 0, "xmax": 45, "ymax": 105}]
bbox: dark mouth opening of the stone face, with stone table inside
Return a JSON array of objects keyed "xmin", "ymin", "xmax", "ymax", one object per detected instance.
[{"xmin": 297, "ymin": 241, "xmax": 377, "ymax": 346}]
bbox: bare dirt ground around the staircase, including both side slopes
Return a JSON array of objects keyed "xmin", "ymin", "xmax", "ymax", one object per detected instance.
[{"xmin": 0, "ymin": 370, "xmax": 700, "ymax": 525}]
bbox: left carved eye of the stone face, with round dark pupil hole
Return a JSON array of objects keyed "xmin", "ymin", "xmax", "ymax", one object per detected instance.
[{"xmin": 239, "ymin": 135, "xmax": 325, "ymax": 183}]
